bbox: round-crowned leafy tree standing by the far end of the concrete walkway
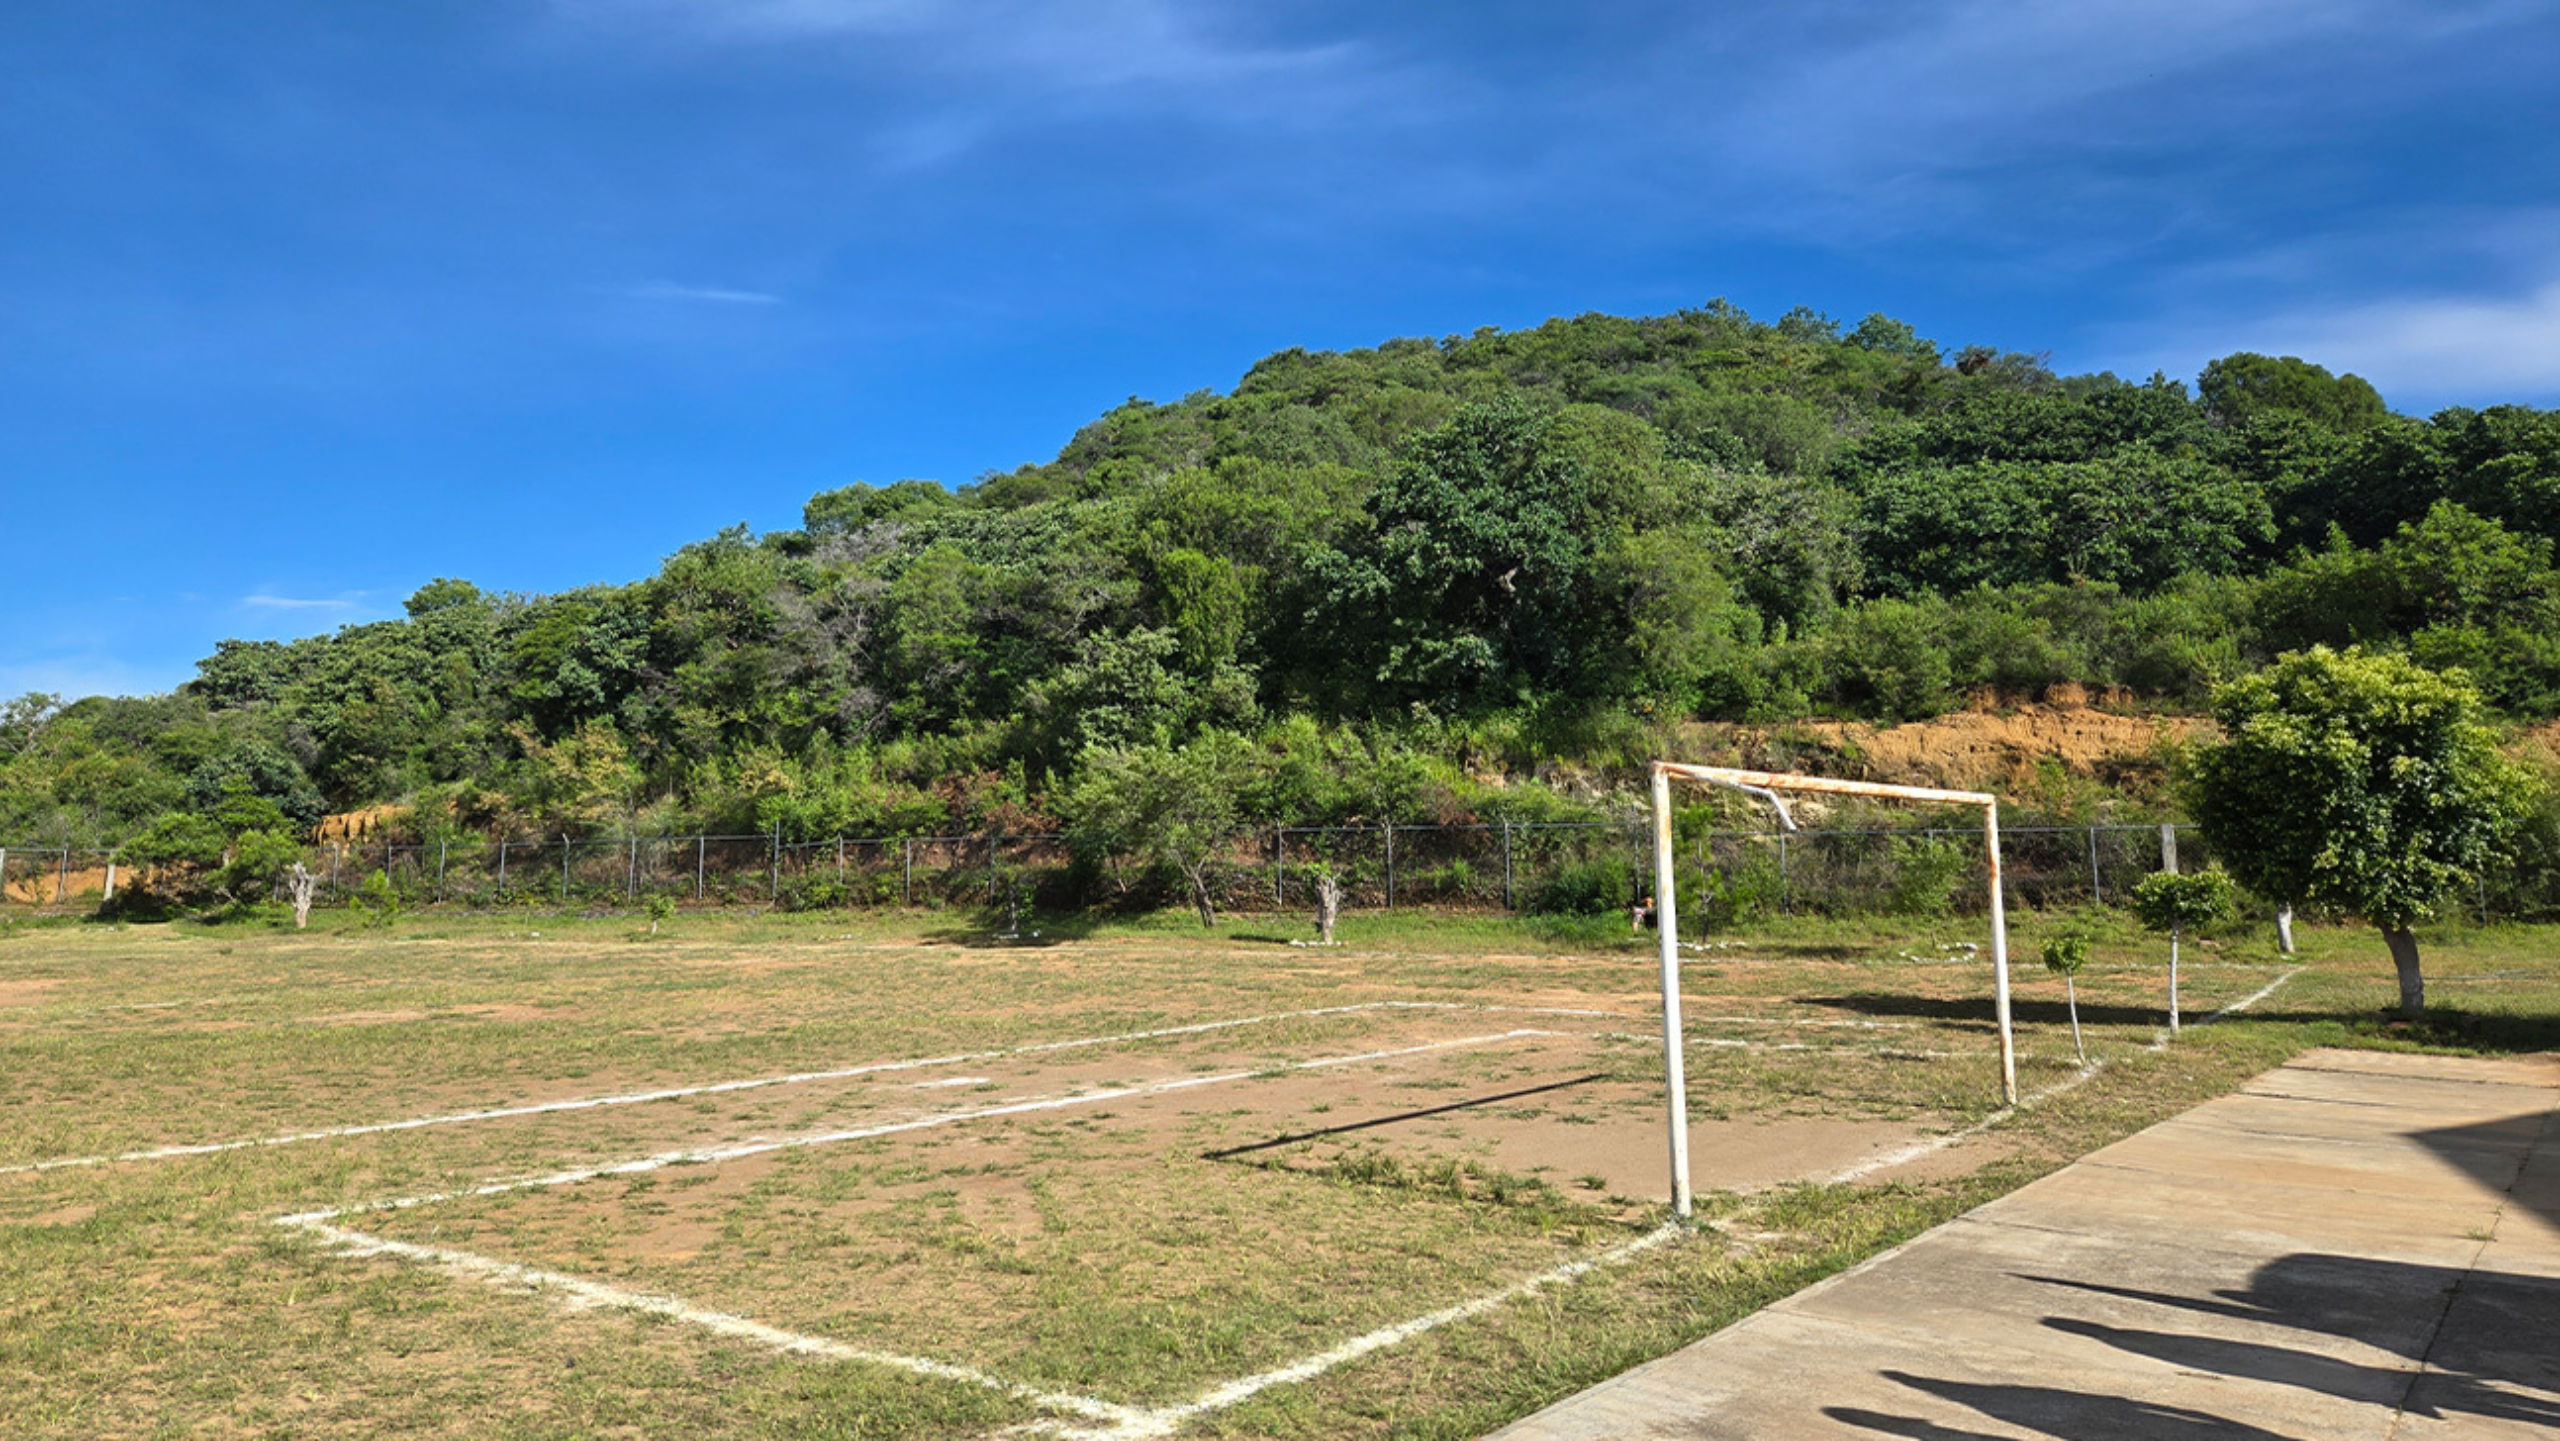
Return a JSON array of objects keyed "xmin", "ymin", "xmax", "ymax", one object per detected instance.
[{"xmin": 2189, "ymin": 645, "xmax": 2532, "ymax": 1019}]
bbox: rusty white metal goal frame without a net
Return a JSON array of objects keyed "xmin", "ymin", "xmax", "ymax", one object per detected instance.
[{"xmin": 1654, "ymin": 760, "xmax": 2017, "ymax": 1216}]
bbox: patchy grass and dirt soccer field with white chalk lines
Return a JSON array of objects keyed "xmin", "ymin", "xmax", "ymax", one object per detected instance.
[{"xmin": 0, "ymin": 916, "xmax": 2552, "ymax": 1436}]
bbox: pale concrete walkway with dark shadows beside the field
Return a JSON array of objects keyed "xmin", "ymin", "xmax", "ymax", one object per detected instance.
[{"xmin": 1495, "ymin": 1052, "xmax": 2560, "ymax": 1441}]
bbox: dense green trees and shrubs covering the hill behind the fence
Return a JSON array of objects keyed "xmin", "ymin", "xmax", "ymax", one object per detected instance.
[{"xmin": 15, "ymin": 302, "xmax": 2560, "ymax": 855}]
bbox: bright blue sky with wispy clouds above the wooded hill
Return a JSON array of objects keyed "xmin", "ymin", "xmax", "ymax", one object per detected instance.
[{"xmin": 0, "ymin": 0, "xmax": 2560, "ymax": 694}]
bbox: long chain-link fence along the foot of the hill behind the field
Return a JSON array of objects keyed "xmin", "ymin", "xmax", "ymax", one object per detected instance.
[{"xmin": 0, "ymin": 822, "xmax": 2437, "ymax": 916}]
